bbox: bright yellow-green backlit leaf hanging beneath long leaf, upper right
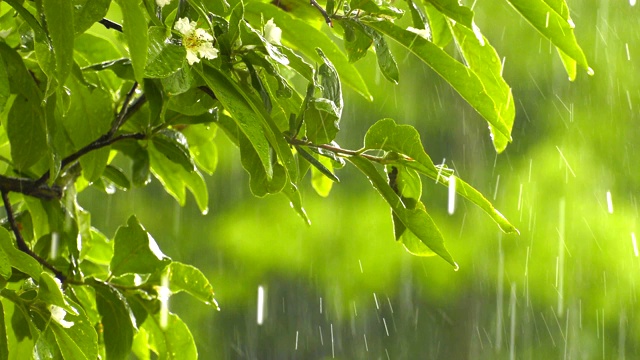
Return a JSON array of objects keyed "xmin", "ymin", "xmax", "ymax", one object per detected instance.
[{"xmin": 451, "ymin": 24, "xmax": 516, "ymax": 153}]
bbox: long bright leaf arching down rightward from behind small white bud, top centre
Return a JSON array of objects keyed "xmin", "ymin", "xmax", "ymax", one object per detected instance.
[{"xmin": 245, "ymin": 1, "xmax": 371, "ymax": 100}]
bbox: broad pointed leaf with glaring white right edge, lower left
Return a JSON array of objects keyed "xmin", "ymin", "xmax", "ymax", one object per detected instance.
[{"xmin": 109, "ymin": 215, "xmax": 171, "ymax": 276}]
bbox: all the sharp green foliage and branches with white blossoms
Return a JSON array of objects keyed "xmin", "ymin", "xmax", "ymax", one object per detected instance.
[{"xmin": 0, "ymin": 0, "xmax": 588, "ymax": 359}]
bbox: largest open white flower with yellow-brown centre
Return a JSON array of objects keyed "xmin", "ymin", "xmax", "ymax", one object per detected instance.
[{"xmin": 173, "ymin": 18, "xmax": 218, "ymax": 65}]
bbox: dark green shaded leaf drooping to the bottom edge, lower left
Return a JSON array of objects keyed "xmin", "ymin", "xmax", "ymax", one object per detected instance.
[{"xmin": 88, "ymin": 279, "xmax": 136, "ymax": 360}]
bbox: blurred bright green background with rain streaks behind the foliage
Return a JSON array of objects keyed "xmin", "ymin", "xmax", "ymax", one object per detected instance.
[{"xmin": 80, "ymin": 0, "xmax": 640, "ymax": 359}]
